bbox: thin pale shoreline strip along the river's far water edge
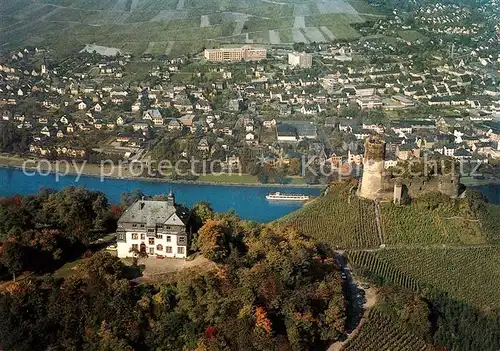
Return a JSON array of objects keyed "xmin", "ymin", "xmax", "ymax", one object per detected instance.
[{"xmin": 0, "ymin": 160, "xmax": 327, "ymax": 189}]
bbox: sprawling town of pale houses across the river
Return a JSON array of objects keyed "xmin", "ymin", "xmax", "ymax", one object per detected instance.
[{"xmin": 0, "ymin": 1, "xmax": 500, "ymax": 184}]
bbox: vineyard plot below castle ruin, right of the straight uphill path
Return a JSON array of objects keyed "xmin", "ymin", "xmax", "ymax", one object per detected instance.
[{"xmin": 381, "ymin": 199, "xmax": 486, "ymax": 245}]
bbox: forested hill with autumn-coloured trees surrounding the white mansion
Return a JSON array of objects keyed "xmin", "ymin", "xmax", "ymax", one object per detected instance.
[{"xmin": 0, "ymin": 188, "xmax": 346, "ymax": 351}]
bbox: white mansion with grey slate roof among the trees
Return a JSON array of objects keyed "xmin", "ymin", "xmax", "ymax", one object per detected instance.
[{"xmin": 116, "ymin": 193, "xmax": 188, "ymax": 258}]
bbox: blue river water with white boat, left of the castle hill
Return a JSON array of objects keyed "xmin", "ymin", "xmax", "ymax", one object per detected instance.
[{"xmin": 0, "ymin": 168, "xmax": 320, "ymax": 222}]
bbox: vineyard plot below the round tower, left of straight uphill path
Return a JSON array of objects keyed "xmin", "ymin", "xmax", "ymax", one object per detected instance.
[{"xmin": 283, "ymin": 182, "xmax": 380, "ymax": 248}]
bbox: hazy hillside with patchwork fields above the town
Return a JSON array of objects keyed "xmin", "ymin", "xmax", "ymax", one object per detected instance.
[{"xmin": 0, "ymin": 0, "xmax": 380, "ymax": 56}]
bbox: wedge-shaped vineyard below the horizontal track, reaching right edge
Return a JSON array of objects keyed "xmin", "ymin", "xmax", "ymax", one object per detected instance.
[{"xmin": 348, "ymin": 247, "xmax": 500, "ymax": 308}]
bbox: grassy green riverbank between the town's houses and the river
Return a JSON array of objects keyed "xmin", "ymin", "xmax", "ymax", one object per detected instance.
[{"xmin": 0, "ymin": 155, "xmax": 326, "ymax": 189}]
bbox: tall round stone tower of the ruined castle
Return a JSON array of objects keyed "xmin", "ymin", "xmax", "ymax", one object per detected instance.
[{"xmin": 359, "ymin": 136, "xmax": 385, "ymax": 200}]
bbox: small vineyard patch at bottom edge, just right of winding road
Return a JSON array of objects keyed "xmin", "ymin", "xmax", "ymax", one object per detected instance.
[{"xmin": 342, "ymin": 310, "xmax": 427, "ymax": 351}]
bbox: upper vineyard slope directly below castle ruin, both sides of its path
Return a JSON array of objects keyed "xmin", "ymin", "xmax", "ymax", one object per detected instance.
[{"xmin": 283, "ymin": 182, "xmax": 500, "ymax": 249}]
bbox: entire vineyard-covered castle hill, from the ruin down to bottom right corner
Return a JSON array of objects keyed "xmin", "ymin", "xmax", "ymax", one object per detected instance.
[{"xmin": 283, "ymin": 182, "xmax": 500, "ymax": 350}]
